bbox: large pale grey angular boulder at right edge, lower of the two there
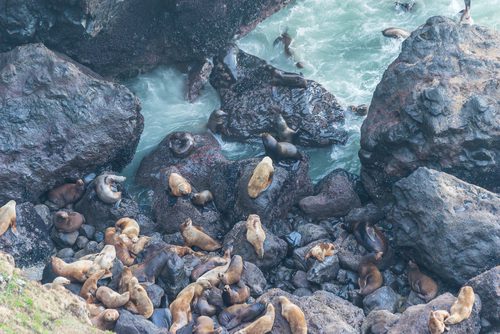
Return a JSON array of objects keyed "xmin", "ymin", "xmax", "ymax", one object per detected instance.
[{"xmin": 388, "ymin": 167, "xmax": 500, "ymax": 285}]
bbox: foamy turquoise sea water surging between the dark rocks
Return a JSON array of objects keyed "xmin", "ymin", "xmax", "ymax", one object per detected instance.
[{"xmin": 124, "ymin": 0, "xmax": 500, "ymax": 188}]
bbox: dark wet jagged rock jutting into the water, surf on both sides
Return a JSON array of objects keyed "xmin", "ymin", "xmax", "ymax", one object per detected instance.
[{"xmin": 210, "ymin": 46, "xmax": 348, "ymax": 146}]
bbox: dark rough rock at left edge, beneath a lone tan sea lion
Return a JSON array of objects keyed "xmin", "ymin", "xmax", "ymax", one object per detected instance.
[{"xmin": 0, "ymin": 202, "xmax": 54, "ymax": 268}]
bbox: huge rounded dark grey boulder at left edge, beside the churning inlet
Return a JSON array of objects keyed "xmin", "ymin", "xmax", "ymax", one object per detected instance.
[{"xmin": 0, "ymin": 42, "xmax": 143, "ymax": 202}]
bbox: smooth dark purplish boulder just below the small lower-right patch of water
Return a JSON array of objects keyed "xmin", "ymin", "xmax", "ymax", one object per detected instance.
[{"xmin": 299, "ymin": 169, "xmax": 361, "ymax": 219}]
